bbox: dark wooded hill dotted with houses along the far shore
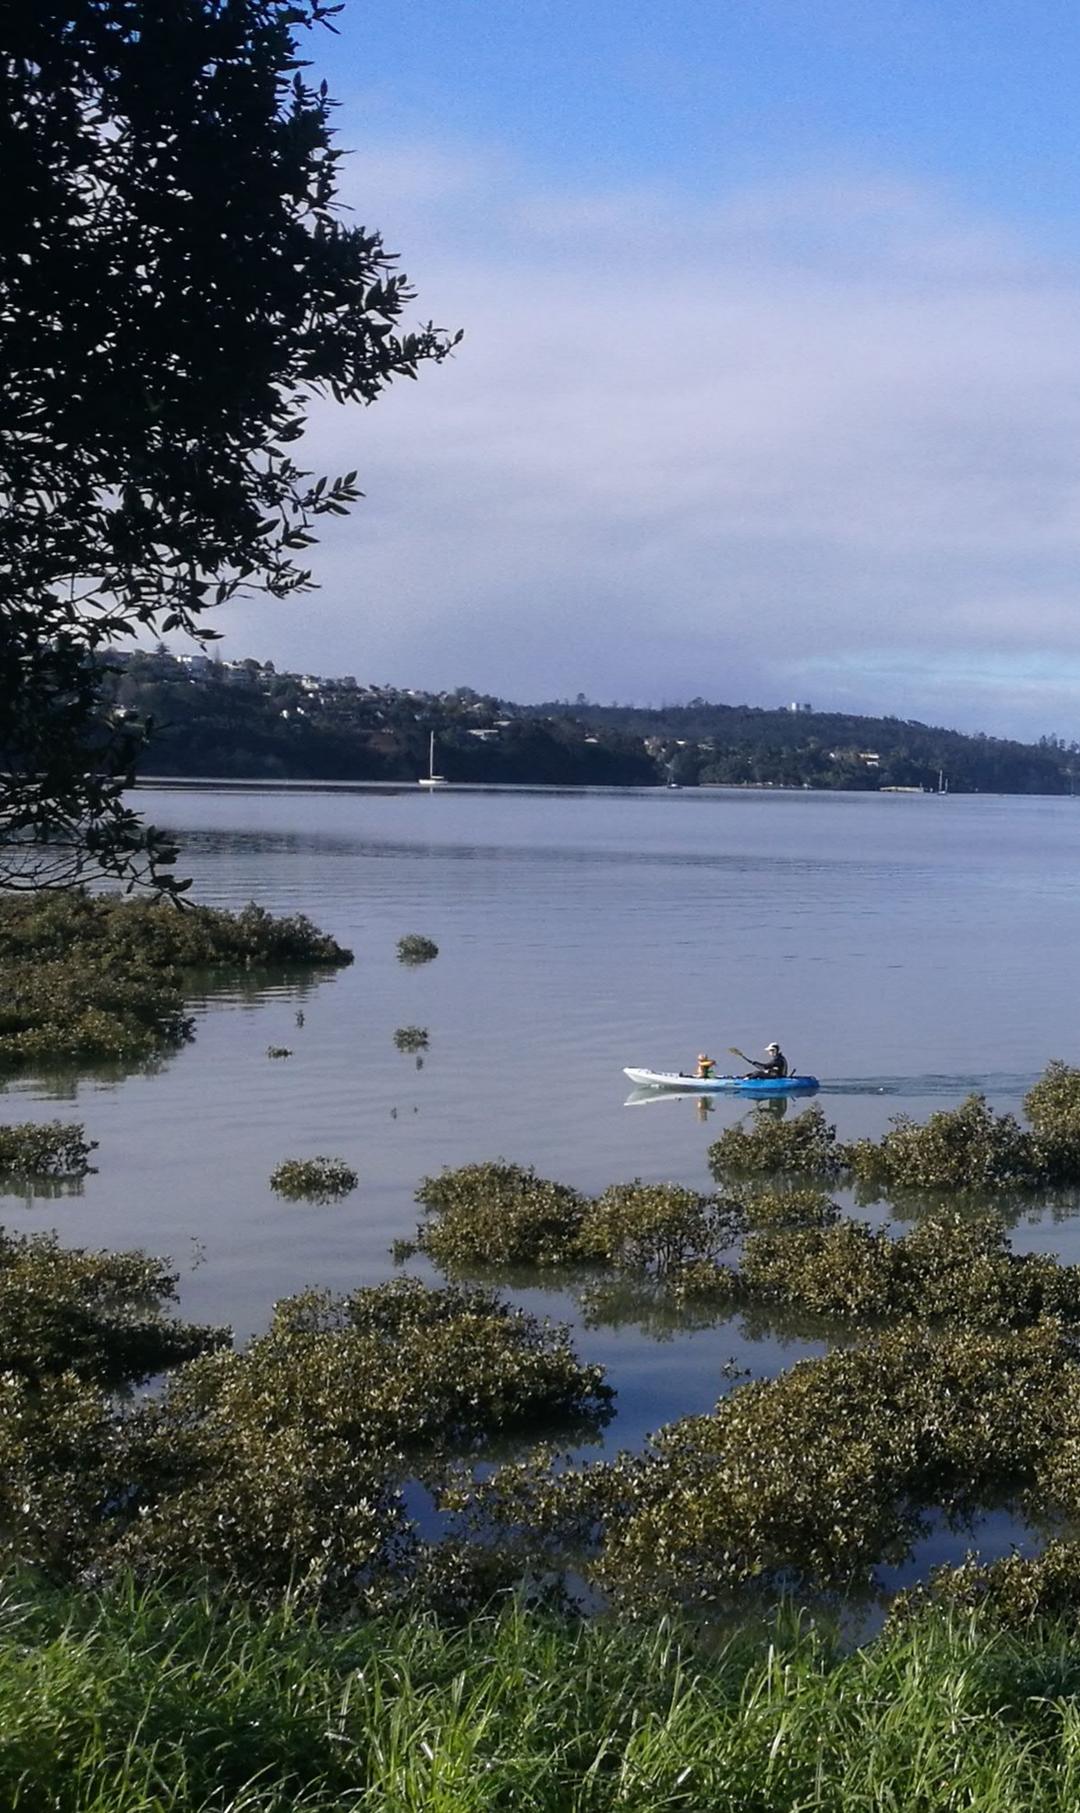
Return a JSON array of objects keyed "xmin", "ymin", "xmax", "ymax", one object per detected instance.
[{"xmin": 103, "ymin": 651, "xmax": 1080, "ymax": 794}]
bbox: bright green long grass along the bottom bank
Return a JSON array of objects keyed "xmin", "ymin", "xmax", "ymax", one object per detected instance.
[{"xmin": 0, "ymin": 1586, "xmax": 1080, "ymax": 1813}]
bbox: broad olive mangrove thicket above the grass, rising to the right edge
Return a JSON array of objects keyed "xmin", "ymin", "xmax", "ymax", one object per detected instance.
[{"xmin": 468, "ymin": 1322, "xmax": 1080, "ymax": 1610}]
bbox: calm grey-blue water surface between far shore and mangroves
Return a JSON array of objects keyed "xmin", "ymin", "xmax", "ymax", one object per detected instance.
[{"xmin": 0, "ymin": 789, "xmax": 1080, "ymax": 1580}]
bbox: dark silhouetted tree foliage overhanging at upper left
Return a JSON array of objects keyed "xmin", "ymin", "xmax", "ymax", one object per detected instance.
[{"xmin": 0, "ymin": 0, "xmax": 455, "ymax": 887}]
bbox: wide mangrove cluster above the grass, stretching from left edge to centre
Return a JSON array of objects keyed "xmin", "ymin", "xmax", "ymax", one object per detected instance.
[{"xmin": 0, "ymin": 1261, "xmax": 611, "ymax": 1599}]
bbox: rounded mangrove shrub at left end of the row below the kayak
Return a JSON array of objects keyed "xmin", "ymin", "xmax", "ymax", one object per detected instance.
[{"xmin": 417, "ymin": 1159, "xmax": 585, "ymax": 1265}]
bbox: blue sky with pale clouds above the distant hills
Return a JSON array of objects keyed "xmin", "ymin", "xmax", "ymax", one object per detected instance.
[{"xmin": 219, "ymin": 0, "xmax": 1080, "ymax": 738}]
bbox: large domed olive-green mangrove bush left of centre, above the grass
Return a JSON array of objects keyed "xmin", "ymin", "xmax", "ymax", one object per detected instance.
[{"xmin": 114, "ymin": 1280, "xmax": 611, "ymax": 1599}]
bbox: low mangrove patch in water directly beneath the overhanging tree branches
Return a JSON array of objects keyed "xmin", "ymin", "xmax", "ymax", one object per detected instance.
[{"xmin": 0, "ymin": 890, "xmax": 352, "ymax": 1062}]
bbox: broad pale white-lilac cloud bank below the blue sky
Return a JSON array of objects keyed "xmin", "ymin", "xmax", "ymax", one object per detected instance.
[{"xmin": 221, "ymin": 147, "xmax": 1080, "ymax": 729}]
